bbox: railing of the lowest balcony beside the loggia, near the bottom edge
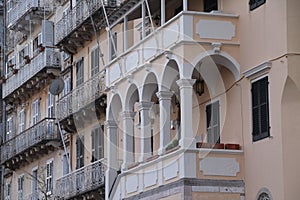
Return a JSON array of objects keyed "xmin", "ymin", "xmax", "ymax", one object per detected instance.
[{"xmin": 56, "ymin": 160, "xmax": 104, "ymax": 199}]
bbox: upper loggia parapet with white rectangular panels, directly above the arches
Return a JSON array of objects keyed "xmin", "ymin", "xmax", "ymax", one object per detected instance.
[{"xmin": 106, "ymin": 11, "xmax": 239, "ymax": 87}]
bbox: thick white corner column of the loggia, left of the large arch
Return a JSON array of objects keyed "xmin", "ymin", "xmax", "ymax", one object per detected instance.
[{"xmin": 176, "ymin": 79, "xmax": 196, "ymax": 148}]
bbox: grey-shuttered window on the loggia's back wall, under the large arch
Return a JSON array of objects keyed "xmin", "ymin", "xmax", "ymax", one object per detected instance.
[{"xmin": 206, "ymin": 101, "xmax": 220, "ymax": 144}]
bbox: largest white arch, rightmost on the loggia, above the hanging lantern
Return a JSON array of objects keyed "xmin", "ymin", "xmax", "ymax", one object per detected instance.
[{"xmin": 192, "ymin": 50, "xmax": 240, "ymax": 81}]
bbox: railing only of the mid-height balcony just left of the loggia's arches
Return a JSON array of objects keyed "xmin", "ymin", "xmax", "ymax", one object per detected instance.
[{"xmin": 56, "ymin": 72, "xmax": 105, "ymax": 119}]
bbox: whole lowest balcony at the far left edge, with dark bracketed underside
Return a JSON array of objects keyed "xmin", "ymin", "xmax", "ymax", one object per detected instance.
[{"xmin": 1, "ymin": 118, "xmax": 60, "ymax": 170}]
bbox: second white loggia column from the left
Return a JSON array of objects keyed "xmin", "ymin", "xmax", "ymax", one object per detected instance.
[{"xmin": 121, "ymin": 111, "xmax": 135, "ymax": 170}]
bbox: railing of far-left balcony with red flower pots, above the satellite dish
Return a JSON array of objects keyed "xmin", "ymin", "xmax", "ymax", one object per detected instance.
[{"xmin": 3, "ymin": 48, "xmax": 60, "ymax": 97}]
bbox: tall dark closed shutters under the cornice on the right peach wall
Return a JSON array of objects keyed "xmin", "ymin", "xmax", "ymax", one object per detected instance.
[{"xmin": 251, "ymin": 77, "xmax": 270, "ymax": 141}]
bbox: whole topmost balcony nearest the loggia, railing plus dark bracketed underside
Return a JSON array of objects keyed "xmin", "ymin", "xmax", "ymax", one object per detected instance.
[{"xmin": 55, "ymin": 0, "xmax": 120, "ymax": 53}]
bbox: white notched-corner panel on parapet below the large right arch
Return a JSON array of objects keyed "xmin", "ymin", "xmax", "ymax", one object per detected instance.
[{"xmin": 200, "ymin": 157, "xmax": 240, "ymax": 176}]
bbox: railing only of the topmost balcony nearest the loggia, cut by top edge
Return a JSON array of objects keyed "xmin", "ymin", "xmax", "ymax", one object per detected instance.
[{"xmin": 55, "ymin": 0, "xmax": 120, "ymax": 44}]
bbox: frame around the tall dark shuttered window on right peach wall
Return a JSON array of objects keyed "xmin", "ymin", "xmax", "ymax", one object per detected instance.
[{"xmin": 251, "ymin": 74, "xmax": 271, "ymax": 142}]
